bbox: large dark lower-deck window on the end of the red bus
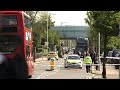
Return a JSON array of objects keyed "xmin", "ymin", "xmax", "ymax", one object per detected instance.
[{"xmin": 0, "ymin": 35, "xmax": 21, "ymax": 54}]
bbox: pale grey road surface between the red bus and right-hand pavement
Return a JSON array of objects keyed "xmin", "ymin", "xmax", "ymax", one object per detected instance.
[{"xmin": 32, "ymin": 58, "xmax": 92, "ymax": 79}]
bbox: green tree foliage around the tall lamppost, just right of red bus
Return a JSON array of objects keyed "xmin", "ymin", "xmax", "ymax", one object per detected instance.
[{"xmin": 30, "ymin": 11, "xmax": 59, "ymax": 51}]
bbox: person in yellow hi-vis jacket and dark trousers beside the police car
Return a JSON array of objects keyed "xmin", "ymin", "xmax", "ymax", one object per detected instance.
[{"xmin": 84, "ymin": 53, "xmax": 92, "ymax": 73}]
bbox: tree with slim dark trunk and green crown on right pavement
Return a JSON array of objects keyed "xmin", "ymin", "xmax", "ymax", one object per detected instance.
[{"xmin": 86, "ymin": 11, "xmax": 119, "ymax": 78}]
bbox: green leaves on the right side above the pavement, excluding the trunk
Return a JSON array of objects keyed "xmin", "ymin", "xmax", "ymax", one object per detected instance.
[{"xmin": 85, "ymin": 11, "xmax": 120, "ymax": 52}]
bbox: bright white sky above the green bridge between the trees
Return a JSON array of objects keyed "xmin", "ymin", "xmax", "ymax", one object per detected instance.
[{"xmin": 48, "ymin": 11, "xmax": 88, "ymax": 26}]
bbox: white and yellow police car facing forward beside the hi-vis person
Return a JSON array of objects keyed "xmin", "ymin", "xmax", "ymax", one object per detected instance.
[{"xmin": 64, "ymin": 54, "xmax": 83, "ymax": 68}]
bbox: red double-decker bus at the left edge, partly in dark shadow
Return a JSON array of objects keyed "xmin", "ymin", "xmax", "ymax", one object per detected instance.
[{"xmin": 0, "ymin": 11, "xmax": 34, "ymax": 79}]
